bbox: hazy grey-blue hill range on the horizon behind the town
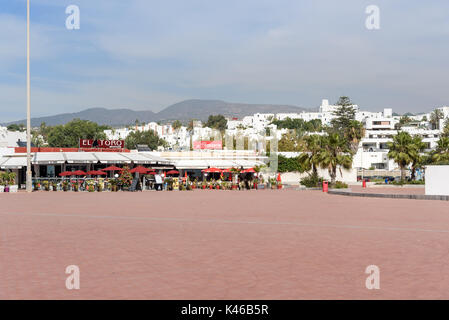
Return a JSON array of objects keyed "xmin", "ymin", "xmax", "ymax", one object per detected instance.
[{"xmin": 6, "ymin": 100, "xmax": 310, "ymax": 127}]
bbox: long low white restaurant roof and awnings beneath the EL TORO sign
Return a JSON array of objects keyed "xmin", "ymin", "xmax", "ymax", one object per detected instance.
[{"xmin": 0, "ymin": 147, "xmax": 267, "ymax": 189}]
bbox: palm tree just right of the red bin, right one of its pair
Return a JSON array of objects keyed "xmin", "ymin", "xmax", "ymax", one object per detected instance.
[{"xmin": 319, "ymin": 133, "xmax": 352, "ymax": 184}]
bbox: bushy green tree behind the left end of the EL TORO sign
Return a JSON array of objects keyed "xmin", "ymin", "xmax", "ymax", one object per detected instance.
[{"xmin": 48, "ymin": 119, "xmax": 109, "ymax": 148}]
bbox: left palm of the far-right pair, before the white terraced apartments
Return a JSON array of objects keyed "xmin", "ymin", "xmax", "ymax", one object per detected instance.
[{"xmin": 388, "ymin": 131, "xmax": 415, "ymax": 181}]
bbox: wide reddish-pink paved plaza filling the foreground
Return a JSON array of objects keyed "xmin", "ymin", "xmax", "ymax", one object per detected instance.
[{"xmin": 0, "ymin": 190, "xmax": 449, "ymax": 299}]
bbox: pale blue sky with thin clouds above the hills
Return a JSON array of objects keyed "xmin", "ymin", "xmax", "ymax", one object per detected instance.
[{"xmin": 0, "ymin": 0, "xmax": 449, "ymax": 123}]
